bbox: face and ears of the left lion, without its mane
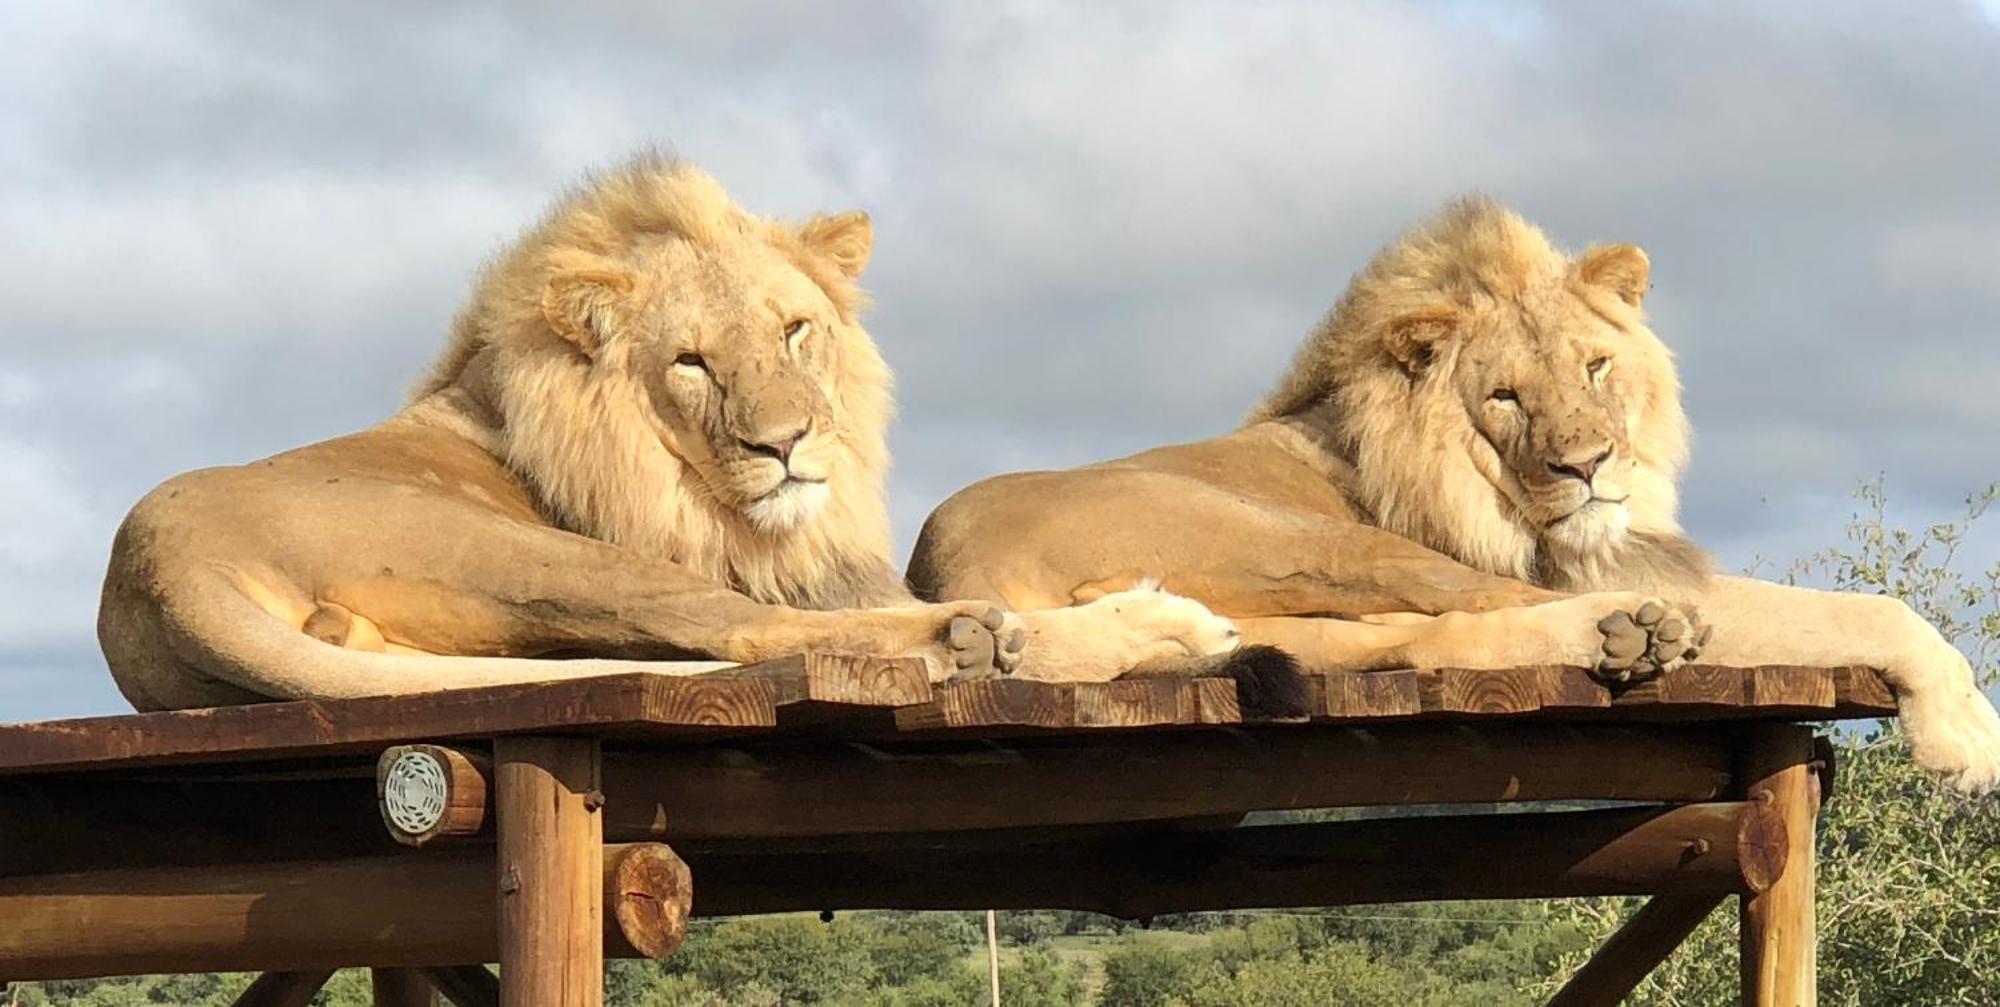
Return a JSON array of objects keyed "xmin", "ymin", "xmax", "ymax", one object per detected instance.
[{"xmin": 528, "ymin": 200, "xmax": 878, "ymax": 533}]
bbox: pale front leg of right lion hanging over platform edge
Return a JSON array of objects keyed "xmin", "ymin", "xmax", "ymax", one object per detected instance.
[{"xmin": 1702, "ymin": 577, "xmax": 2000, "ymax": 793}]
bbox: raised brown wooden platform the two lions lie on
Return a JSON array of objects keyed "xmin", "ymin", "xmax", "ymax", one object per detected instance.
[{"xmin": 0, "ymin": 655, "xmax": 1894, "ymax": 1007}]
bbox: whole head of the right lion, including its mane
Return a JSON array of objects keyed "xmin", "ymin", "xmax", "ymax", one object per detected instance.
[{"xmin": 1252, "ymin": 198, "xmax": 1694, "ymax": 587}]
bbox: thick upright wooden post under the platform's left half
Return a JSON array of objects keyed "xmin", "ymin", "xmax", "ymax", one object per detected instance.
[{"xmin": 494, "ymin": 735, "xmax": 604, "ymax": 1007}]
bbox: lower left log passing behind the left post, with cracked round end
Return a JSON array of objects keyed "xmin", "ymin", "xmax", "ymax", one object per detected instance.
[{"xmin": 0, "ymin": 845, "xmax": 690, "ymax": 979}]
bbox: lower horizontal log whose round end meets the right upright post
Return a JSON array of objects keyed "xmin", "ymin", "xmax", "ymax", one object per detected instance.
[{"xmin": 692, "ymin": 801, "xmax": 1784, "ymax": 919}]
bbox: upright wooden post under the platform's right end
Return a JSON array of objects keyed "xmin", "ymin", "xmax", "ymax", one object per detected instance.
[{"xmin": 1740, "ymin": 725, "xmax": 1820, "ymax": 1007}]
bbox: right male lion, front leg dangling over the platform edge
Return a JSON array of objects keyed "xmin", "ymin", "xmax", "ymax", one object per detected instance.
[{"xmin": 910, "ymin": 198, "xmax": 2000, "ymax": 791}]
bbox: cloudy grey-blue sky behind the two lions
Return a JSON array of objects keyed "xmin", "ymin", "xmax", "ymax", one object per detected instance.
[{"xmin": 0, "ymin": 0, "xmax": 2000, "ymax": 721}]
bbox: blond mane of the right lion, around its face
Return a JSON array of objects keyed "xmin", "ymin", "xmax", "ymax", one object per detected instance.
[{"xmin": 1248, "ymin": 196, "xmax": 1710, "ymax": 595}]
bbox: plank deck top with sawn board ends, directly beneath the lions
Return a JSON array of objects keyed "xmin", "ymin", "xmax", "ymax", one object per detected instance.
[{"xmin": 0, "ymin": 655, "xmax": 1894, "ymax": 775}]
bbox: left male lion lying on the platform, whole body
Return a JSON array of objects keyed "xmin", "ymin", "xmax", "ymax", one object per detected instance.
[{"xmin": 98, "ymin": 156, "xmax": 1236, "ymax": 709}]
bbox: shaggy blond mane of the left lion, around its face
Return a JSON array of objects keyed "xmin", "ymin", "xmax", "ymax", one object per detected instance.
[{"xmin": 414, "ymin": 154, "xmax": 894, "ymax": 609}]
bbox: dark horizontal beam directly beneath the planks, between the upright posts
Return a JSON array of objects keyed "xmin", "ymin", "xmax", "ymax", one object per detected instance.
[{"xmin": 604, "ymin": 723, "xmax": 1732, "ymax": 845}]
